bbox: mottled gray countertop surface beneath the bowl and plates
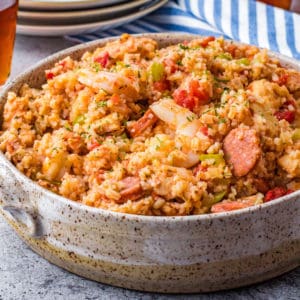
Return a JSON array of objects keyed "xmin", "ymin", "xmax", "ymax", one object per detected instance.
[{"xmin": 0, "ymin": 36, "xmax": 300, "ymax": 300}]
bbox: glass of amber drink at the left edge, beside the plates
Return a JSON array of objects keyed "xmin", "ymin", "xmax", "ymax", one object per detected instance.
[{"xmin": 0, "ymin": 0, "xmax": 18, "ymax": 86}]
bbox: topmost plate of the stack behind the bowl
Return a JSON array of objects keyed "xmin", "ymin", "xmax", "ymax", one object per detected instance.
[{"xmin": 19, "ymin": 0, "xmax": 127, "ymax": 10}]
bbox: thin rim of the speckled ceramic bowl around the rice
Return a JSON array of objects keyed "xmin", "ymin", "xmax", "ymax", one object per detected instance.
[{"xmin": 0, "ymin": 32, "xmax": 300, "ymax": 223}]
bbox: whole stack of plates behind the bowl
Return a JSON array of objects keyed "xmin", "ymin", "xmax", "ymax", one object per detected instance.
[{"xmin": 17, "ymin": 0, "xmax": 168, "ymax": 36}]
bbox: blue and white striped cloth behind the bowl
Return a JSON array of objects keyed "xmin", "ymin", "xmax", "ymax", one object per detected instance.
[{"xmin": 69, "ymin": 0, "xmax": 300, "ymax": 59}]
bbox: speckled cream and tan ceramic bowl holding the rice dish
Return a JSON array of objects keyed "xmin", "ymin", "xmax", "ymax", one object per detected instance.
[{"xmin": 0, "ymin": 34, "xmax": 300, "ymax": 293}]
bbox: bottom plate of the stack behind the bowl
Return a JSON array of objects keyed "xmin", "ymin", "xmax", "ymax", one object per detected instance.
[{"xmin": 17, "ymin": 0, "xmax": 168, "ymax": 36}]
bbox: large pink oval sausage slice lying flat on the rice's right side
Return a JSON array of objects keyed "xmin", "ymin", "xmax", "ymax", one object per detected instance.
[{"xmin": 223, "ymin": 127, "xmax": 261, "ymax": 177}]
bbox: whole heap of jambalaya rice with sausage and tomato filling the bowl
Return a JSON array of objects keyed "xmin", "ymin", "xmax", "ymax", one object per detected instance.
[{"xmin": 0, "ymin": 35, "xmax": 300, "ymax": 216}]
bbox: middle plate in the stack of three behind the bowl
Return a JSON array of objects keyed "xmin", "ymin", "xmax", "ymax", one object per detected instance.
[{"xmin": 17, "ymin": 0, "xmax": 152, "ymax": 25}]
